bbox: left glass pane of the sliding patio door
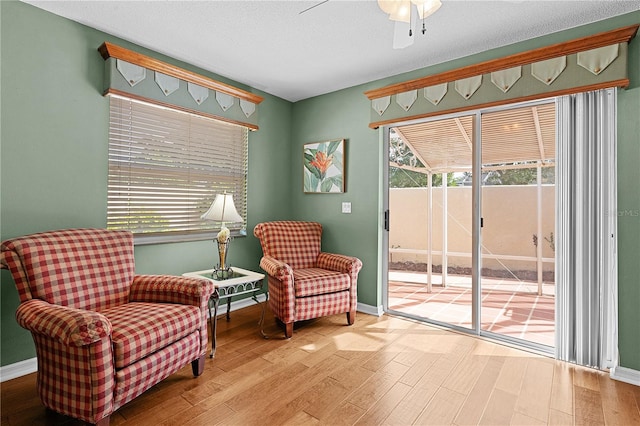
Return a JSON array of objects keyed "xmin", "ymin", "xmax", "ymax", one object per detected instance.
[{"xmin": 388, "ymin": 116, "xmax": 473, "ymax": 328}]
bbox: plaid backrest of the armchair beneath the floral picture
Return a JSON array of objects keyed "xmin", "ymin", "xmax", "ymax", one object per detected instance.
[{"xmin": 253, "ymin": 221, "xmax": 322, "ymax": 269}]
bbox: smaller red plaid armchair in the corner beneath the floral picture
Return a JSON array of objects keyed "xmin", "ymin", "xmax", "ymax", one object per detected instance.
[{"xmin": 253, "ymin": 221, "xmax": 362, "ymax": 338}]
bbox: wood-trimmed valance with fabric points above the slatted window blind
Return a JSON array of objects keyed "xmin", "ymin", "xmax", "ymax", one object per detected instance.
[{"xmin": 98, "ymin": 42, "xmax": 263, "ymax": 130}]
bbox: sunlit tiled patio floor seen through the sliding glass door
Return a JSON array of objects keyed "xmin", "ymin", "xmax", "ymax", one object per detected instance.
[{"xmin": 389, "ymin": 271, "xmax": 555, "ymax": 347}]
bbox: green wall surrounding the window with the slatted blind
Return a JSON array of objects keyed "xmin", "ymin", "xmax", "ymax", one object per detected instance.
[{"xmin": 0, "ymin": 1, "xmax": 292, "ymax": 365}]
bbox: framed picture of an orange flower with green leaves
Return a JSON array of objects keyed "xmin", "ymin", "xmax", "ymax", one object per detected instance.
[{"xmin": 303, "ymin": 139, "xmax": 344, "ymax": 194}]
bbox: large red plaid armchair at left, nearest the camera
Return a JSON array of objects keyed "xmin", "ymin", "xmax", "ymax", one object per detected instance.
[{"xmin": 0, "ymin": 229, "xmax": 214, "ymax": 425}]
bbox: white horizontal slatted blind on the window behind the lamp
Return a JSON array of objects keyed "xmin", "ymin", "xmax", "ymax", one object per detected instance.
[{"xmin": 107, "ymin": 96, "xmax": 248, "ymax": 243}]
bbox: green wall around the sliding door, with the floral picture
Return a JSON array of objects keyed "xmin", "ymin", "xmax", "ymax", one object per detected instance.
[{"xmin": 291, "ymin": 12, "xmax": 640, "ymax": 370}]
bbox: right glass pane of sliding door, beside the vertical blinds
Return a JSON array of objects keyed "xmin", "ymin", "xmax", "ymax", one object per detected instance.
[{"xmin": 481, "ymin": 103, "xmax": 555, "ymax": 346}]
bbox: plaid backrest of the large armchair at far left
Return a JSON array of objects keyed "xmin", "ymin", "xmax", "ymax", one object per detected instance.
[{"xmin": 0, "ymin": 229, "xmax": 135, "ymax": 311}]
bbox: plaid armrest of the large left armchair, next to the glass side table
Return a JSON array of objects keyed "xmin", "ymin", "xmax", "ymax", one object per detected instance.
[{"xmin": 129, "ymin": 275, "xmax": 215, "ymax": 309}]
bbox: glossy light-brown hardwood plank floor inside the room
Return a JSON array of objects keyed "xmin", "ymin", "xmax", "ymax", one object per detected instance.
[{"xmin": 0, "ymin": 307, "xmax": 640, "ymax": 426}]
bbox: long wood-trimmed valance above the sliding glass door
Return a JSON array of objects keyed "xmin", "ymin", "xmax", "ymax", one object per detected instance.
[{"xmin": 365, "ymin": 25, "xmax": 639, "ymax": 129}]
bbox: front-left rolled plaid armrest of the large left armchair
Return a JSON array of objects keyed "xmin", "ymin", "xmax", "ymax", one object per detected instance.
[{"xmin": 16, "ymin": 299, "xmax": 111, "ymax": 346}]
